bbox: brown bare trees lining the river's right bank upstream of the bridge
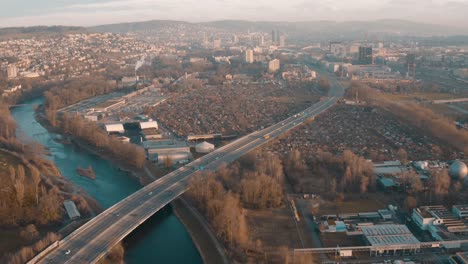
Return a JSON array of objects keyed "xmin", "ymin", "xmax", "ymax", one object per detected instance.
[{"xmin": 46, "ymin": 110, "xmax": 146, "ymax": 168}]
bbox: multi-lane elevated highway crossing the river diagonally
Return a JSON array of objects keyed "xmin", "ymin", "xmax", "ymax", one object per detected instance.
[{"xmin": 34, "ymin": 74, "xmax": 344, "ymax": 263}]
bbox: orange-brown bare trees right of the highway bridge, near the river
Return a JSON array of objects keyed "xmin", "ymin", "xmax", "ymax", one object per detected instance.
[{"xmin": 188, "ymin": 154, "xmax": 284, "ymax": 262}]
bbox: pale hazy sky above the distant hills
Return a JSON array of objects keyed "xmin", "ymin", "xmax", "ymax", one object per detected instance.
[{"xmin": 0, "ymin": 0, "xmax": 468, "ymax": 27}]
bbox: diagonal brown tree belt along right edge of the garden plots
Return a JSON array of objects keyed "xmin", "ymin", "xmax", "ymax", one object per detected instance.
[{"xmin": 347, "ymin": 82, "xmax": 468, "ymax": 153}]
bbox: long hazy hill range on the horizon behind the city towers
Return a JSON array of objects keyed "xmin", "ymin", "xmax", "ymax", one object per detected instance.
[{"xmin": 88, "ymin": 19, "xmax": 468, "ymax": 37}]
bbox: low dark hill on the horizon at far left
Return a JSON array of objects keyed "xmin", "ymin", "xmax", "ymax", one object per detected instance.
[{"xmin": 0, "ymin": 26, "xmax": 86, "ymax": 39}]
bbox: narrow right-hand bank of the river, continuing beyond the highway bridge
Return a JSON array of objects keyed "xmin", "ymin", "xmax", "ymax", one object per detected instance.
[{"xmin": 35, "ymin": 102, "xmax": 222, "ymax": 263}]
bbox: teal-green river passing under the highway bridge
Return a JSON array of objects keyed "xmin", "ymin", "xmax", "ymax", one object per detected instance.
[{"xmin": 11, "ymin": 98, "xmax": 202, "ymax": 264}]
